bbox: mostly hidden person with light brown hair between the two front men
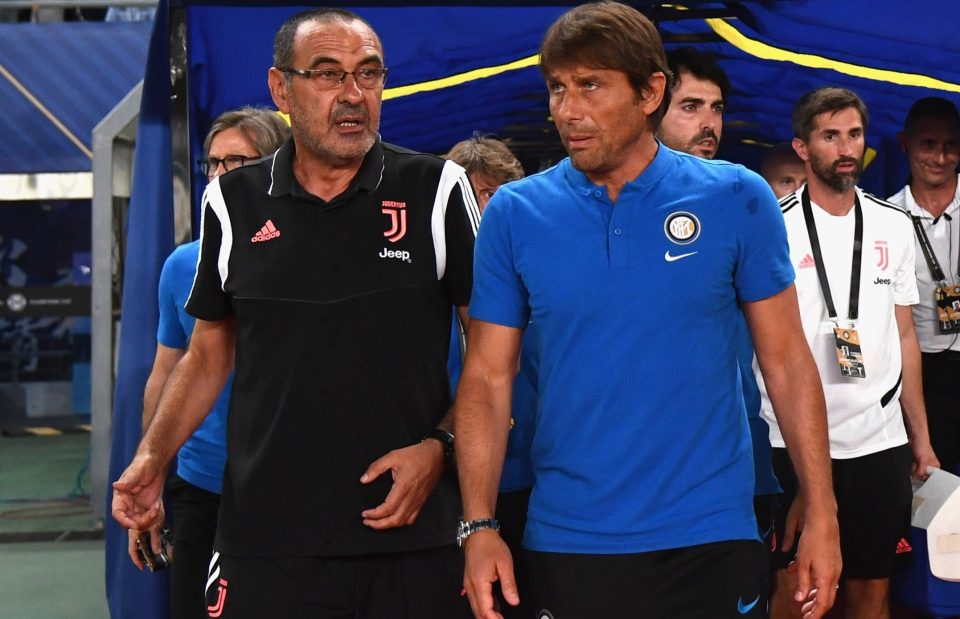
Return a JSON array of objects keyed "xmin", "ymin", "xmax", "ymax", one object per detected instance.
[{"xmin": 446, "ymin": 133, "xmax": 538, "ymax": 619}]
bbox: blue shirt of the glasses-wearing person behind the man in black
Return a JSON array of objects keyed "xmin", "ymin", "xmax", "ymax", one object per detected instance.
[{"xmin": 157, "ymin": 241, "xmax": 233, "ymax": 494}]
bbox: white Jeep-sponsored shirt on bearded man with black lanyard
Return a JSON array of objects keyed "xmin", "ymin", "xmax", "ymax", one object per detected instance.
[{"xmin": 754, "ymin": 187, "xmax": 917, "ymax": 459}]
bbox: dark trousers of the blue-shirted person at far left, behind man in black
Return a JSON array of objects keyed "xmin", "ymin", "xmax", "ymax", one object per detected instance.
[{"xmin": 166, "ymin": 475, "xmax": 220, "ymax": 619}]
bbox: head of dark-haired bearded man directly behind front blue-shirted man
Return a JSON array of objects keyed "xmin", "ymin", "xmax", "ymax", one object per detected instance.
[{"xmin": 657, "ymin": 47, "xmax": 730, "ymax": 159}]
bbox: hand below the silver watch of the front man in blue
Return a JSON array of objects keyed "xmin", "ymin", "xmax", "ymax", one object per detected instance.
[{"xmin": 463, "ymin": 529, "xmax": 520, "ymax": 619}]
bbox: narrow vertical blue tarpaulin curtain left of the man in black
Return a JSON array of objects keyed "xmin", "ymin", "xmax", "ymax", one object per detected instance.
[{"xmin": 105, "ymin": 7, "xmax": 173, "ymax": 619}]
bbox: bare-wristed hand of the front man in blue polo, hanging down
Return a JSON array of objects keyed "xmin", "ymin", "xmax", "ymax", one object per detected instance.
[{"xmin": 790, "ymin": 507, "xmax": 843, "ymax": 619}]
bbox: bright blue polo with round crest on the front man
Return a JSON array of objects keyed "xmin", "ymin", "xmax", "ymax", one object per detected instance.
[{"xmin": 470, "ymin": 145, "xmax": 794, "ymax": 554}]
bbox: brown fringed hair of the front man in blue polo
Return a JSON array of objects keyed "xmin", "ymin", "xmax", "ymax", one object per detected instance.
[{"xmin": 540, "ymin": 1, "xmax": 672, "ymax": 128}]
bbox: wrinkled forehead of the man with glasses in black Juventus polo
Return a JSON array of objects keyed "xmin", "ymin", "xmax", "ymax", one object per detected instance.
[{"xmin": 293, "ymin": 20, "xmax": 383, "ymax": 64}]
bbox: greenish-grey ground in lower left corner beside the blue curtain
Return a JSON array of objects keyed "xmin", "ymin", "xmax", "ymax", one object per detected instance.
[{"xmin": 0, "ymin": 433, "xmax": 109, "ymax": 619}]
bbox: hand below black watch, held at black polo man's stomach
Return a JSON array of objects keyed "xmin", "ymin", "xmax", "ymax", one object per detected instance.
[{"xmin": 360, "ymin": 440, "xmax": 444, "ymax": 529}]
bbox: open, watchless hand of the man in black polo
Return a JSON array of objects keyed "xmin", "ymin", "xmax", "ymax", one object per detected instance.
[{"xmin": 111, "ymin": 454, "xmax": 166, "ymax": 531}]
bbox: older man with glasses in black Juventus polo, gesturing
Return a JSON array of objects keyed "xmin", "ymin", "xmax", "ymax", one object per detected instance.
[{"xmin": 113, "ymin": 8, "xmax": 479, "ymax": 619}]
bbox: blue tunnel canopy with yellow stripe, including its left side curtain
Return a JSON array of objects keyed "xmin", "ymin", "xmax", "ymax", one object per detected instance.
[{"xmin": 107, "ymin": 0, "xmax": 960, "ymax": 619}]
